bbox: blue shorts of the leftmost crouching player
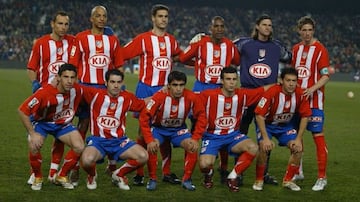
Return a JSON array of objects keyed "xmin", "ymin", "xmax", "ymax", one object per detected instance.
[{"xmin": 33, "ymin": 122, "xmax": 77, "ymax": 139}]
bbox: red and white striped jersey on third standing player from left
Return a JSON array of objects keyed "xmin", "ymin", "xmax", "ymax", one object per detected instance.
[{"xmin": 123, "ymin": 31, "xmax": 181, "ymax": 86}]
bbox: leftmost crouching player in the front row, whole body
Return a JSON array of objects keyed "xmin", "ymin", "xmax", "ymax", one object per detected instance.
[{"xmin": 18, "ymin": 64, "xmax": 84, "ymax": 190}]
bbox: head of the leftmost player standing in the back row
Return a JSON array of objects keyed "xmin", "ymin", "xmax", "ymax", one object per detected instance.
[{"xmin": 50, "ymin": 11, "xmax": 70, "ymax": 40}]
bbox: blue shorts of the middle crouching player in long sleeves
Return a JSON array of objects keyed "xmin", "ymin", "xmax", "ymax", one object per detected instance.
[{"xmin": 152, "ymin": 126, "xmax": 191, "ymax": 147}]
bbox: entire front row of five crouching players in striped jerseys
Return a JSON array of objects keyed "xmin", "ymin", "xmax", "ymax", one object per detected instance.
[{"xmin": 18, "ymin": 64, "xmax": 311, "ymax": 192}]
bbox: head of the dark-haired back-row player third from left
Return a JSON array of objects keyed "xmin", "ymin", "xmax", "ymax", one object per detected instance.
[{"xmin": 151, "ymin": 4, "xmax": 169, "ymax": 30}]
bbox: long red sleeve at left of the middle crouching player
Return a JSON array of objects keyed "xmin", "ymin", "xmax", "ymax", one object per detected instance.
[{"xmin": 139, "ymin": 93, "xmax": 162, "ymax": 144}]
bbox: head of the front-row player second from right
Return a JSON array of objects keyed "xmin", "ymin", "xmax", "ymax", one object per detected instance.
[{"xmin": 220, "ymin": 67, "xmax": 238, "ymax": 95}]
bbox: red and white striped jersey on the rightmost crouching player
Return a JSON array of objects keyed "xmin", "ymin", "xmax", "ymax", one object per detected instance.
[{"xmin": 255, "ymin": 84, "xmax": 311, "ymax": 124}]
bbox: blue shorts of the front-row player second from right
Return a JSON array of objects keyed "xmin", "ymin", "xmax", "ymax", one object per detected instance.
[{"xmin": 200, "ymin": 131, "xmax": 249, "ymax": 156}]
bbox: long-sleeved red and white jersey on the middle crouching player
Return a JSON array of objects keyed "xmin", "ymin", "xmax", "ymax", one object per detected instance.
[{"xmin": 139, "ymin": 89, "xmax": 207, "ymax": 143}]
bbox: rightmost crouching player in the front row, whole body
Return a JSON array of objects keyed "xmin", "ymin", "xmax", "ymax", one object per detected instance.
[{"xmin": 253, "ymin": 68, "xmax": 311, "ymax": 191}]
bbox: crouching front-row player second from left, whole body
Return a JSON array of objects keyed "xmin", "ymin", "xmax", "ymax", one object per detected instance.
[{"xmin": 81, "ymin": 69, "xmax": 148, "ymax": 190}]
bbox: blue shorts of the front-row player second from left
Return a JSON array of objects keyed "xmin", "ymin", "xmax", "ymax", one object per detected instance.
[{"xmin": 86, "ymin": 135, "xmax": 136, "ymax": 163}]
